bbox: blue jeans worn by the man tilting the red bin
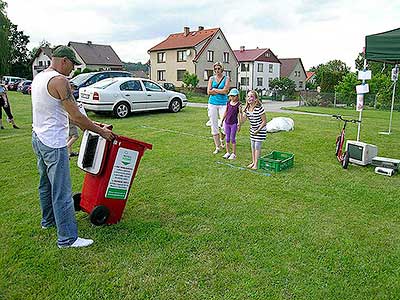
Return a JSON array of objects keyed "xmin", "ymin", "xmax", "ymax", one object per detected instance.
[{"xmin": 32, "ymin": 132, "xmax": 78, "ymax": 246}]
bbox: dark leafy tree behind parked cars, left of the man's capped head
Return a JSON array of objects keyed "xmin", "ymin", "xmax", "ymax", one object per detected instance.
[{"xmin": 8, "ymin": 23, "xmax": 31, "ymax": 77}]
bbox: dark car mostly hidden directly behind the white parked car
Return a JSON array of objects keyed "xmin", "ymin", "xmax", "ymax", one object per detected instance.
[{"xmin": 70, "ymin": 71, "xmax": 132, "ymax": 99}]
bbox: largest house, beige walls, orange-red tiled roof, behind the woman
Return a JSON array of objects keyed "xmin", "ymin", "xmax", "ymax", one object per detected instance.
[{"xmin": 148, "ymin": 26, "xmax": 238, "ymax": 87}]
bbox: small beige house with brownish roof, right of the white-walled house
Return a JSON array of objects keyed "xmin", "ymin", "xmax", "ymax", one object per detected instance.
[{"xmin": 279, "ymin": 57, "xmax": 307, "ymax": 91}]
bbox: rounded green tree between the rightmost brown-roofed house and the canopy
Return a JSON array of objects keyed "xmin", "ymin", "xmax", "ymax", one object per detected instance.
[{"xmin": 310, "ymin": 59, "xmax": 350, "ymax": 92}]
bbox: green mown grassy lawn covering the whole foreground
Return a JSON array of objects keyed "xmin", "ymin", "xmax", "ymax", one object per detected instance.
[{"xmin": 0, "ymin": 93, "xmax": 400, "ymax": 299}]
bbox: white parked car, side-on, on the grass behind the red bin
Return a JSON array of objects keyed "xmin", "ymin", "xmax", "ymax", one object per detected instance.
[{"xmin": 78, "ymin": 77, "xmax": 187, "ymax": 118}]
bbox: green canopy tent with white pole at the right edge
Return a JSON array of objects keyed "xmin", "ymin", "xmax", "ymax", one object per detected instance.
[{"xmin": 365, "ymin": 28, "xmax": 400, "ymax": 134}]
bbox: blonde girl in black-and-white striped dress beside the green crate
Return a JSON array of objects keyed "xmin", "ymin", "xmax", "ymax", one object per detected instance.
[{"xmin": 242, "ymin": 91, "xmax": 267, "ymax": 169}]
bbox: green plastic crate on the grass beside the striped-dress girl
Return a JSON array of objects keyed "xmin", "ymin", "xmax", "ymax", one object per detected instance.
[{"xmin": 257, "ymin": 151, "xmax": 294, "ymax": 172}]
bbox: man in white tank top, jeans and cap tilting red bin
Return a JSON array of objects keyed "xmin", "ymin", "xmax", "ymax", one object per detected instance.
[{"xmin": 32, "ymin": 46, "xmax": 114, "ymax": 248}]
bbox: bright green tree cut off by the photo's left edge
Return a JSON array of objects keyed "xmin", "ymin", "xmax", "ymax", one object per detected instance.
[{"xmin": 0, "ymin": 0, "xmax": 11, "ymax": 75}]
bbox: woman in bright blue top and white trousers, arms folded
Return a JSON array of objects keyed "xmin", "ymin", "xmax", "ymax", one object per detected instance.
[{"xmin": 207, "ymin": 62, "xmax": 230, "ymax": 154}]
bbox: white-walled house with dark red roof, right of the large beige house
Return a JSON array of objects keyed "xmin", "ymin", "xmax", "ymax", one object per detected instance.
[{"xmin": 234, "ymin": 46, "xmax": 280, "ymax": 90}]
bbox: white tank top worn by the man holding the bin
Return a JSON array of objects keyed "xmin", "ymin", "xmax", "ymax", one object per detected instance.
[{"xmin": 32, "ymin": 71, "xmax": 69, "ymax": 148}]
